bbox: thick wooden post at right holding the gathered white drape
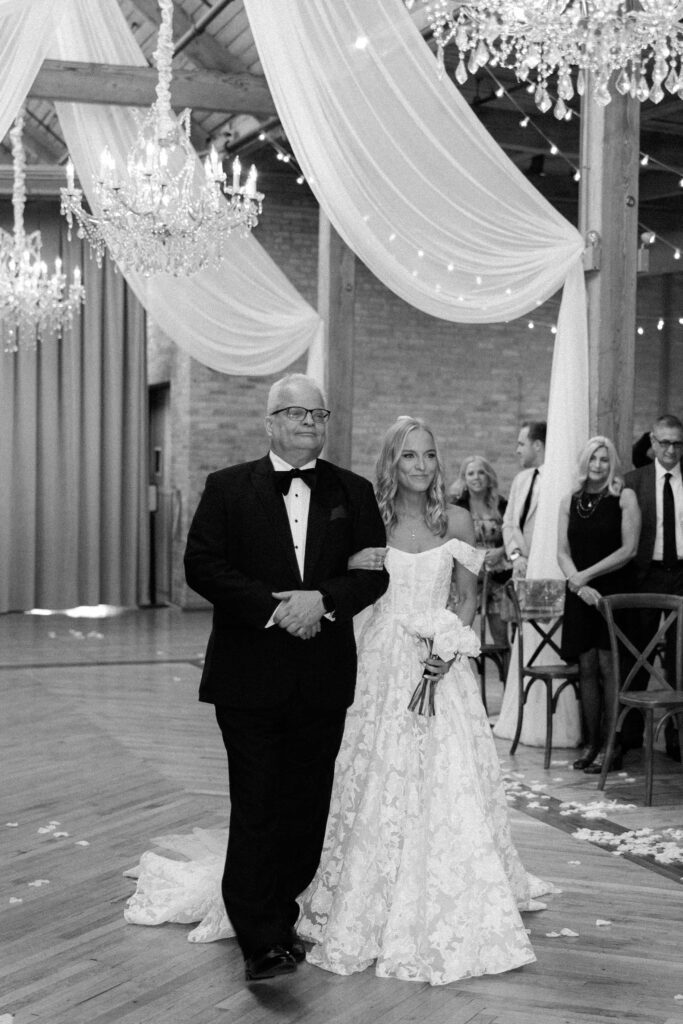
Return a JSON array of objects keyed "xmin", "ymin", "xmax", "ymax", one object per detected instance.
[{"xmin": 579, "ymin": 88, "xmax": 640, "ymax": 467}]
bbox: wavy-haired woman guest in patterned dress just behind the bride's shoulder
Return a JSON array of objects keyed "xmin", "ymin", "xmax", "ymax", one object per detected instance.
[{"xmin": 449, "ymin": 455, "xmax": 512, "ymax": 645}]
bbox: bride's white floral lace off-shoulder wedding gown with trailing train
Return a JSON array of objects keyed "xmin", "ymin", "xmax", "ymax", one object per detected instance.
[{"xmin": 126, "ymin": 541, "xmax": 554, "ymax": 985}]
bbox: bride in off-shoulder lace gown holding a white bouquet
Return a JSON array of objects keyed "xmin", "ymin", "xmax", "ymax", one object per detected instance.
[{"xmin": 297, "ymin": 417, "xmax": 548, "ymax": 985}]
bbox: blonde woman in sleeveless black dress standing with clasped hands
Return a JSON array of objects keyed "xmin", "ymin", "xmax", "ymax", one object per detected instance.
[{"xmin": 557, "ymin": 436, "xmax": 640, "ymax": 774}]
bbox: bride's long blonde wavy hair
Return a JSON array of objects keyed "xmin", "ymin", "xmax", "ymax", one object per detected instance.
[{"xmin": 375, "ymin": 416, "xmax": 449, "ymax": 537}]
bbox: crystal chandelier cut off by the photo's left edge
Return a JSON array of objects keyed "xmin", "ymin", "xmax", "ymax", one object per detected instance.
[{"xmin": 0, "ymin": 111, "xmax": 85, "ymax": 352}]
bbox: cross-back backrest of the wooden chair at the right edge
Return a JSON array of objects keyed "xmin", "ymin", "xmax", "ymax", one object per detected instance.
[{"xmin": 598, "ymin": 594, "xmax": 683, "ymax": 692}]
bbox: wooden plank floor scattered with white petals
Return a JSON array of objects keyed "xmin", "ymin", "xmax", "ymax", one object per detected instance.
[{"xmin": 0, "ymin": 609, "xmax": 683, "ymax": 1024}]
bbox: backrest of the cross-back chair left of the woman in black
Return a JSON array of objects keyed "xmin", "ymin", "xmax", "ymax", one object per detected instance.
[{"xmin": 505, "ymin": 580, "xmax": 565, "ymax": 667}]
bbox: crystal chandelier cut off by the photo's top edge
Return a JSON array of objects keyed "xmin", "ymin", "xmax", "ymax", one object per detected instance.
[{"xmin": 421, "ymin": 0, "xmax": 683, "ymax": 118}]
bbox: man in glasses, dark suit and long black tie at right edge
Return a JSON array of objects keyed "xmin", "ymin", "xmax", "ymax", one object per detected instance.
[{"xmin": 622, "ymin": 415, "xmax": 683, "ymax": 761}]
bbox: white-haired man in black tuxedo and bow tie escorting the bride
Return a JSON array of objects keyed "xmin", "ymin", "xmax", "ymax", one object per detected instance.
[{"xmin": 185, "ymin": 374, "xmax": 388, "ymax": 980}]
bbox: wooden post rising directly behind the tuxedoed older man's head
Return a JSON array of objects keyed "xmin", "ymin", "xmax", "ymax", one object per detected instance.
[{"xmin": 317, "ymin": 210, "xmax": 355, "ymax": 469}]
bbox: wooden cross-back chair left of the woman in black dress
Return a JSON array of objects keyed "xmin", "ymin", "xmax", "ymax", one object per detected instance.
[{"xmin": 506, "ymin": 580, "xmax": 579, "ymax": 768}]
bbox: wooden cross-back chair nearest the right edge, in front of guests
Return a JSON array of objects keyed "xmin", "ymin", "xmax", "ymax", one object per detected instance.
[{"xmin": 598, "ymin": 594, "xmax": 683, "ymax": 807}]
